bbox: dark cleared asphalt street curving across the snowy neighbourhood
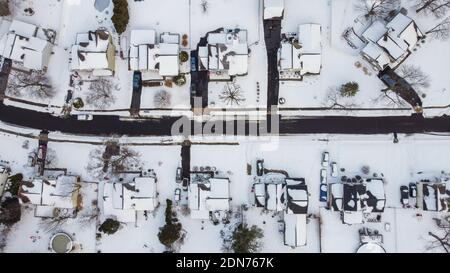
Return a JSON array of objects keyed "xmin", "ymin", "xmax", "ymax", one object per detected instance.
[{"xmin": 0, "ymin": 103, "xmax": 450, "ymax": 136}]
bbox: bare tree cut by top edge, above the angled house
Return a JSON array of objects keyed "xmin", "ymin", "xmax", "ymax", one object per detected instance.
[{"xmin": 354, "ymin": 0, "xmax": 401, "ymax": 20}]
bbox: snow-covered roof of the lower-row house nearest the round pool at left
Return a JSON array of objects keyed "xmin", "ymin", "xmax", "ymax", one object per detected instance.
[{"xmin": 21, "ymin": 175, "xmax": 79, "ymax": 209}]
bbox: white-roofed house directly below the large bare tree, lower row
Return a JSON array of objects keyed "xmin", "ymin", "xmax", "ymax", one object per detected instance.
[{"xmin": 103, "ymin": 176, "xmax": 159, "ymax": 223}]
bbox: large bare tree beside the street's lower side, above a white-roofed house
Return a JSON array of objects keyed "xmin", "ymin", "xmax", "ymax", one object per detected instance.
[{"xmin": 86, "ymin": 141, "xmax": 141, "ymax": 179}]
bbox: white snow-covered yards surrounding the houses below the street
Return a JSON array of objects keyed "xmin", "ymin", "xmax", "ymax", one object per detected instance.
[{"xmin": 0, "ymin": 129, "xmax": 450, "ymax": 252}]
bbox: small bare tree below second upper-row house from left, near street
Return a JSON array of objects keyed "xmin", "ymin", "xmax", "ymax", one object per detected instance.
[{"xmin": 86, "ymin": 78, "xmax": 116, "ymax": 109}]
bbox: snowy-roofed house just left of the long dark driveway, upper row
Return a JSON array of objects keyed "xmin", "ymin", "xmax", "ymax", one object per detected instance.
[{"xmin": 198, "ymin": 29, "xmax": 249, "ymax": 80}]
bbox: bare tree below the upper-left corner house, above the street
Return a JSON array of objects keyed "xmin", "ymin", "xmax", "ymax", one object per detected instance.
[{"xmin": 7, "ymin": 70, "xmax": 56, "ymax": 99}]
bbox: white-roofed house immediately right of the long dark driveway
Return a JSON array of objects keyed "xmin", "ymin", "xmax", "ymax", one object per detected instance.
[{"xmin": 278, "ymin": 24, "xmax": 322, "ymax": 76}]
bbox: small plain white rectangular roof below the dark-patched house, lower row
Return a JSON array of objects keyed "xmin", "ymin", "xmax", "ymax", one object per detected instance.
[{"xmin": 284, "ymin": 213, "xmax": 307, "ymax": 247}]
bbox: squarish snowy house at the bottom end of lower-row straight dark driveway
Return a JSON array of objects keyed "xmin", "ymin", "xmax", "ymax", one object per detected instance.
[{"xmin": 188, "ymin": 177, "xmax": 231, "ymax": 220}]
